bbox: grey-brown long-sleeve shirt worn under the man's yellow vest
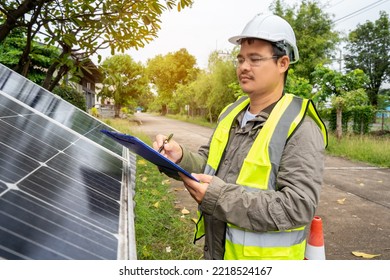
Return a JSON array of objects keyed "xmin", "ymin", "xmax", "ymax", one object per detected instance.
[{"xmin": 172, "ymin": 106, "xmax": 324, "ymax": 259}]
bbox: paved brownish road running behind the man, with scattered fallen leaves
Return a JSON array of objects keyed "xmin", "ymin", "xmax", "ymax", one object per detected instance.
[{"xmin": 131, "ymin": 113, "xmax": 390, "ymax": 260}]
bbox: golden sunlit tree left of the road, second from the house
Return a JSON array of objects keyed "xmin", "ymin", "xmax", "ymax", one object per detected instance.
[{"xmin": 147, "ymin": 49, "xmax": 198, "ymax": 115}]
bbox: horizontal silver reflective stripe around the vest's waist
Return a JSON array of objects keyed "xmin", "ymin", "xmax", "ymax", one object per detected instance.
[{"xmin": 226, "ymin": 227, "xmax": 306, "ymax": 247}]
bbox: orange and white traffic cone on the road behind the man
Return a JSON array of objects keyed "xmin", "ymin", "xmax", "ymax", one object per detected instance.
[{"xmin": 305, "ymin": 216, "xmax": 325, "ymax": 260}]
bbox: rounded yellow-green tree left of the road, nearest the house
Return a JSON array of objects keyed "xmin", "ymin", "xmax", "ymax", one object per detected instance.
[{"xmin": 99, "ymin": 54, "xmax": 149, "ymax": 117}]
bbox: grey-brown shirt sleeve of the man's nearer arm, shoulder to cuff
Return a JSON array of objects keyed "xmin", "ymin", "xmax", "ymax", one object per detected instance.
[{"xmin": 200, "ymin": 117, "xmax": 324, "ymax": 231}]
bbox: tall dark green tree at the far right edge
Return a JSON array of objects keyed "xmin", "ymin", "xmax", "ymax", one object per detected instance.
[{"xmin": 345, "ymin": 11, "xmax": 390, "ymax": 107}]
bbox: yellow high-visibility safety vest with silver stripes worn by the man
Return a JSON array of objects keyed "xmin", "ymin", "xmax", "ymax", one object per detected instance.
[{"xmin": 195, "ymin": 94, "xmax": 328, "ymax": 260}]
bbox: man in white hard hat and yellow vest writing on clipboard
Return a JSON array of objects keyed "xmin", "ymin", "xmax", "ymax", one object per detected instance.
[{"xmin": 153, "ymin": 14, "xmax": 327, "ymax": 260}]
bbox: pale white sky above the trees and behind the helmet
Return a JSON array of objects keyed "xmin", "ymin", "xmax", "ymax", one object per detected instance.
[{"xmin": 96, "ymin": 0, "xmax": 390, "ymax": 68}]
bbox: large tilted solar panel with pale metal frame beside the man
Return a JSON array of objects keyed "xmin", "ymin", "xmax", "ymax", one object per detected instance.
[{"xmin": 0, "ymin": 64, "xmax": 136, "ymax": 260}]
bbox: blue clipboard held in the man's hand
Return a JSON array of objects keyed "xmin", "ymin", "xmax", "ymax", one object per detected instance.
[{"xmin": 101, "ymin": 129, "xmax": 199, "ymax": 182}]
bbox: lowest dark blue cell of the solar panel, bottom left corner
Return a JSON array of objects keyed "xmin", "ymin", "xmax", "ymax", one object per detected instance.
[{"xmin": 0, "ymin": 190, "xmax": 118, "ymax": 259}]
